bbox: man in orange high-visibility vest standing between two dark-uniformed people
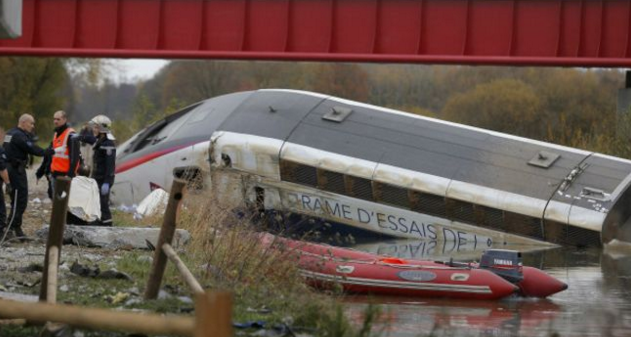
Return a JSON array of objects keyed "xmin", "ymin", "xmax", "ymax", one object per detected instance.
[{"xmin": 50, "ymin": 110, "xmax": 79, "ymax": 182}]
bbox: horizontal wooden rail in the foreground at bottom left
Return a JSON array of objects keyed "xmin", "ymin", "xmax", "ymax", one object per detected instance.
[{"xmin": 0, "ymin": 300, "xmax": 195, "ymax": 336}]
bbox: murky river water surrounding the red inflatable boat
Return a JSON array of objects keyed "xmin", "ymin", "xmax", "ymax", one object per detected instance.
[{"xmin": 340, "ymin": 241, "xmax": 631, "ymax": 336}]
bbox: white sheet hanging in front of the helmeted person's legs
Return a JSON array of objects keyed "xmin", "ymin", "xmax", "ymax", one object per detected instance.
[{"xmin": 68, "ymin": 176, "xmax": 101, "ymax": 222}]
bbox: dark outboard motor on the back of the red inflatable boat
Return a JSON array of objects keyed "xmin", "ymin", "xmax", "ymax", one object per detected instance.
[{"xmin": 480, "ymin": 249, "xmax": 524, "ymax": 284}]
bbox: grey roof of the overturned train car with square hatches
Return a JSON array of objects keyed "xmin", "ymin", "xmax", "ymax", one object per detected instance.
[{"xmin": 219, "ymin": 89, "xmax": 631, "ymax": 208}]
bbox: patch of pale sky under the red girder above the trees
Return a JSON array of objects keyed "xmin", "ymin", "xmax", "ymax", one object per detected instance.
[{"xmin": 109, "ymin": 59, "xmax": 169, "ymax": 83}]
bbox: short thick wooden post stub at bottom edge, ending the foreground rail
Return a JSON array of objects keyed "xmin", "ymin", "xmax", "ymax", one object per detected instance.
[{"xmin": 193, "ymin": 291, "xmax": 232, "ymax": 337}]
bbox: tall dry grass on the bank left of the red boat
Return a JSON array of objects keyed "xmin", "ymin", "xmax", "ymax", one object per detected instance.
[{"xmin": 173, "ymin": 193, "xmax": 378, "ymax": 336}]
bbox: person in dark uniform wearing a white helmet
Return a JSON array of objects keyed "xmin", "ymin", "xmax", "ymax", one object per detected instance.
[{"xmin": 76, "ymin": 115, "xmax": 116, "ymax": 226}]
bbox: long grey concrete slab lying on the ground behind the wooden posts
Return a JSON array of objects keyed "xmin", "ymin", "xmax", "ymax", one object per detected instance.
[{"xmin": 35, "ymin": 225, "xmax": 191, "ymax": 249}]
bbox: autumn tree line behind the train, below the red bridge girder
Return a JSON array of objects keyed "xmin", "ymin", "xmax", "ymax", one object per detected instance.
[{"xmin": 0, "ymin": 58, "xmax": 631, "ymax": 158}]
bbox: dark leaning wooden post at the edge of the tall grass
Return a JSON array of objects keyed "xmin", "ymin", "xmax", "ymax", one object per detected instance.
[{"xmin": 145, "ymin": 179, "xmax": 186, "ymax": 300}]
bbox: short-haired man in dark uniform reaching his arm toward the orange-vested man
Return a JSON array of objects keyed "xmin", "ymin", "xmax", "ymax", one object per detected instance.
[{"xmin": 4, "ymin": 114, "xmax": 54, "ymax": 237}]
